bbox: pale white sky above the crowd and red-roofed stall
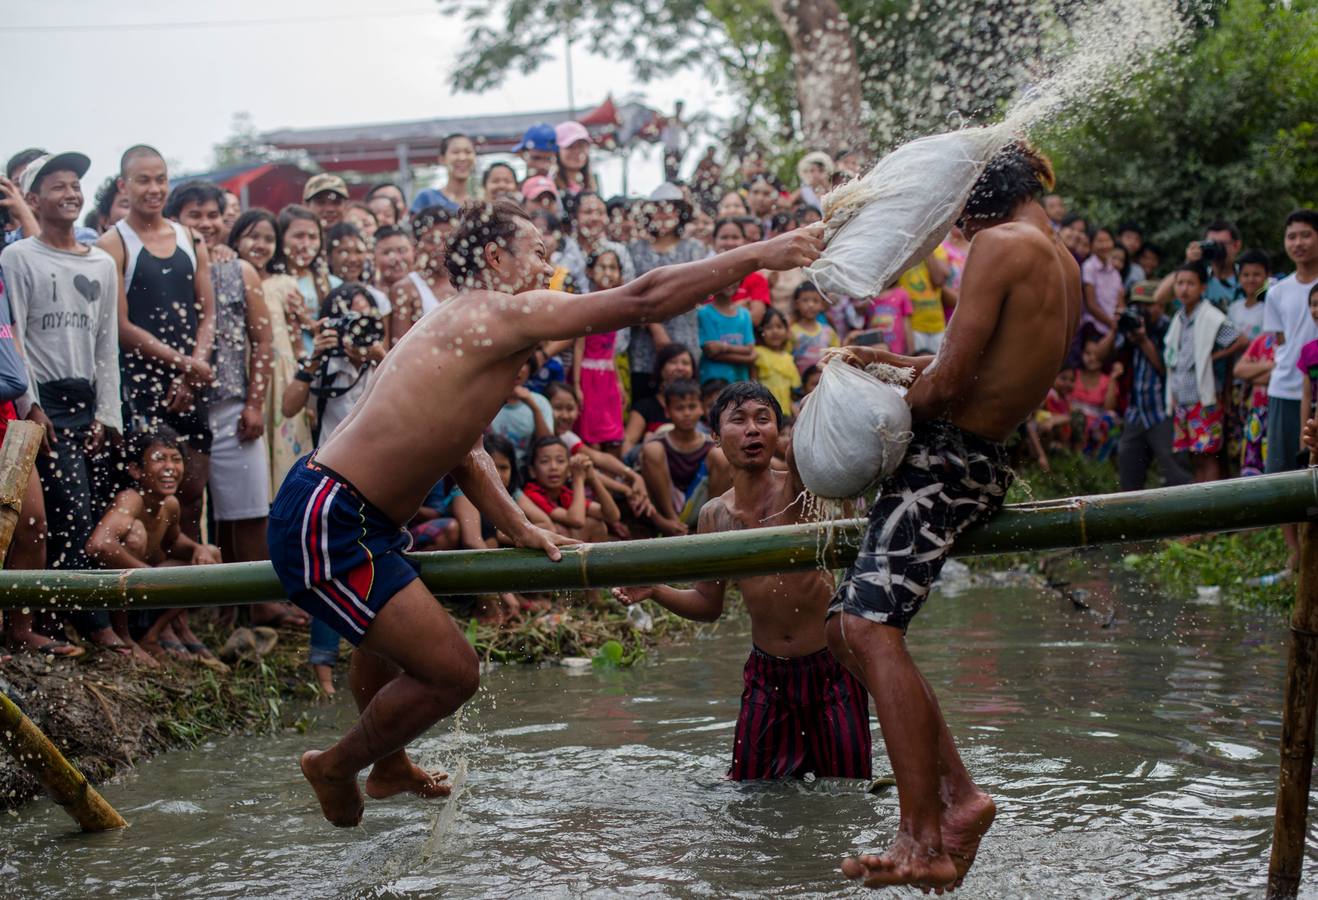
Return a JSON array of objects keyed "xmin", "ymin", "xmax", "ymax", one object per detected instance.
[{"xmin": 0, "ymin": 0, "xmax": 733, "ymax": 214}]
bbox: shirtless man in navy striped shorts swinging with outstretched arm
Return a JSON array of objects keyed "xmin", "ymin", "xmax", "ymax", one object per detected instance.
[{"xmin": 269, "ymin": 200, "xmax": 822, "ymax": 826}]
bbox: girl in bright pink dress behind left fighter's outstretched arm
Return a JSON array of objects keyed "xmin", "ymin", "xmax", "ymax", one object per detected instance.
[{"xmin": 572, "ymin": 250, "xmax": 623, "ymax": 452}]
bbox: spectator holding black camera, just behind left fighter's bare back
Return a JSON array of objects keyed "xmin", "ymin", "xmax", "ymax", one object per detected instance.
[{"xmin": 281, "ymin": 281, "xmax": 385, "ymax": 447}]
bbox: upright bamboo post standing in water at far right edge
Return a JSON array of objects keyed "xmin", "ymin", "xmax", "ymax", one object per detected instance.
[{"xmin": 1268, "ymin": 453, "xmax": 1318, "ymax": 899}]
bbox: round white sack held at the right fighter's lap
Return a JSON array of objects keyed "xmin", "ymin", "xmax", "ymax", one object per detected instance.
[{"xmin": 792, "ymin": 360, "xmax": 913, "ymax": 499}]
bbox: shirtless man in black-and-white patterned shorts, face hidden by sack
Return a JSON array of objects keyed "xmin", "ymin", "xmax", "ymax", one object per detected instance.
[{"xmin": 828, "ymin": 142, "xmax": 1081, "ymax": 889}]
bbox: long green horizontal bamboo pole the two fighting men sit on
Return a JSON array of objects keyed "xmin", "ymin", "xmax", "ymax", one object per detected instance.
[{"xmin": 0, "ymin": 470, "xmax": 1318, "ymax": 609}]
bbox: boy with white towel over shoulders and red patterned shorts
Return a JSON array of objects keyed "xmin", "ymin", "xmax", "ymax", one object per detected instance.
[{"xmin": 1162, "ymin": 262, "xmax": 1246, "ymax": 481}]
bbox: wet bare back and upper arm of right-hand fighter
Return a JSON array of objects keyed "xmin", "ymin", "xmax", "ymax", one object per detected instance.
[{"xmin": 923, "ymin": 212, "xmax": 1081, "ymax": 441}]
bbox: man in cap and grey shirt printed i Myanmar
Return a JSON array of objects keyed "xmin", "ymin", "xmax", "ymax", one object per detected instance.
[{"xmin": 0, "ymin": 153, "xmax": 137, "ymax": 664}]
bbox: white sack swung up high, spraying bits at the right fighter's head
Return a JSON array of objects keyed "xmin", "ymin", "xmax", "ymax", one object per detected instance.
[{"xmin": 807, "ymin": 125, "xmax": 1011, "ymax": 299}]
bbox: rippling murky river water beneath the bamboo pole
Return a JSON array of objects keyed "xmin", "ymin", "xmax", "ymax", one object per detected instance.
[{"xmin": 0, "ymin": 574, "xmax": 1318, "ymax": 897}]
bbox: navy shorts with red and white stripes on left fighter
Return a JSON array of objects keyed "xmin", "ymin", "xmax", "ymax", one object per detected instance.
[{"xmin": 268, "ymin": 456, "xmax": 420, "ymax": 647}]
